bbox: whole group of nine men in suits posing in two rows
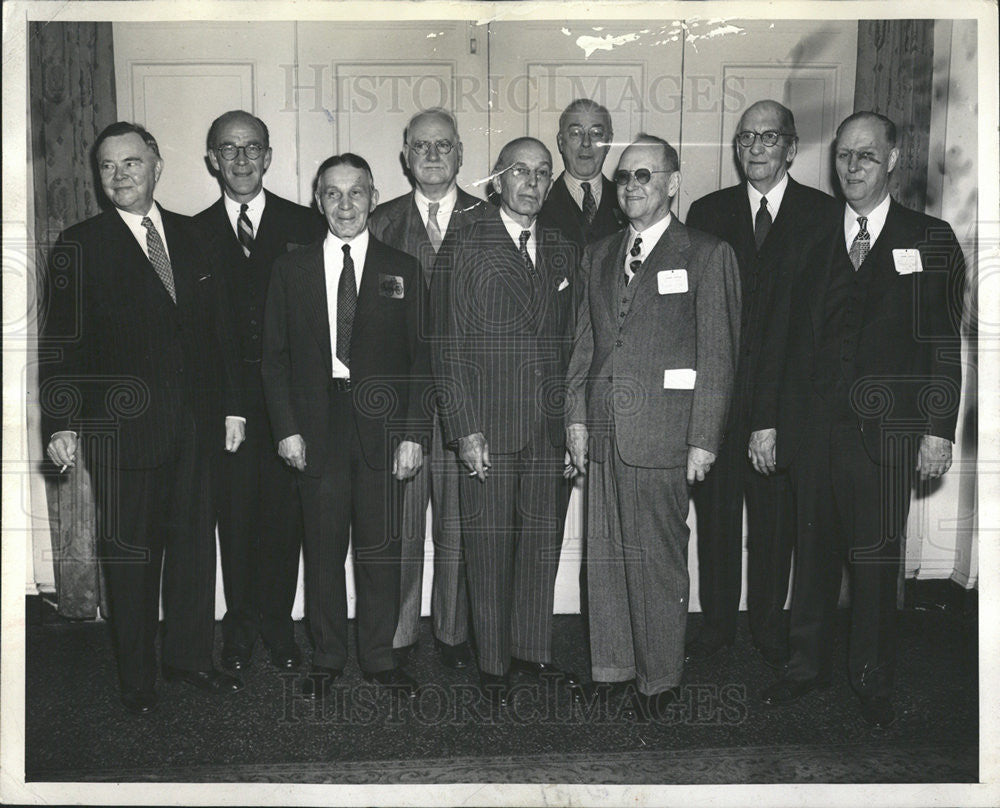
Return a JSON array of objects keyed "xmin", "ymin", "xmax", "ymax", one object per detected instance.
[{"xmin": 41, "ymin": 99, "xmax": 964, "ymax": 726}]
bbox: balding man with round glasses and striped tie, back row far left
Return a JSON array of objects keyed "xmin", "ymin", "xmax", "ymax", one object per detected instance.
[{"xmin": 195, "ymin": 110, "xmax": 324, "ymax": 671}]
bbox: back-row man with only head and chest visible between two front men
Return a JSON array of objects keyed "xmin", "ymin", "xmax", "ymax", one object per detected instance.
[{"xmin": 539, "ymin": 98, "xmax": 625, "ymax": 254}]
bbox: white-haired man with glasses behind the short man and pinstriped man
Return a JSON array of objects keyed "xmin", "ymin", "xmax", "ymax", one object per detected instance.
[{"xmin": 369, "ymin": 107, "xmax": 488, "ymax": 668}]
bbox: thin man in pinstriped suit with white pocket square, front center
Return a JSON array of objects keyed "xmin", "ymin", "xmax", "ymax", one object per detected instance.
[{"xmin": 432, "ymin": 138, "xmax": 576, "ymax": 706}]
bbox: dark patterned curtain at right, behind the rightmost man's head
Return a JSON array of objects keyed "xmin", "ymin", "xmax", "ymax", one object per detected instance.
[{"xmin": 854, "ymin": 20, "xmax": 934, "ymax": 211}]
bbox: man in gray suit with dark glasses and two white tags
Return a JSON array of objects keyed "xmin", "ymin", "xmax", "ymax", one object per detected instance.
[{"xmin": 566, "ymin": 135, "xmax": 740, "ymax": 717}]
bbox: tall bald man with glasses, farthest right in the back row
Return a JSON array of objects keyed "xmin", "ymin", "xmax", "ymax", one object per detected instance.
[{"xmin": 686, "ymin": 100, "xmax": 838, "ymax": 668}]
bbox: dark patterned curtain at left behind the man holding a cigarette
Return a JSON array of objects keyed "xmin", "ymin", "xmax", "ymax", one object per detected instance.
[{"xmin": 28, "ymin": 22, "xmax": 118, "ymax": 618}]
